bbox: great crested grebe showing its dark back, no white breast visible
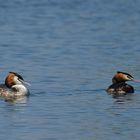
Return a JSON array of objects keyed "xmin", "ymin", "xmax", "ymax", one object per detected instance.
[{"xmin": 106, "ymin": 71, "xmax": 139, "ymax": 96}]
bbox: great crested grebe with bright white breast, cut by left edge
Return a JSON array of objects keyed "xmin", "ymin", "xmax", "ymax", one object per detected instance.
[{"xmin": 0, "ymin": 72, "xmax": 29, "ymax": 98}]
